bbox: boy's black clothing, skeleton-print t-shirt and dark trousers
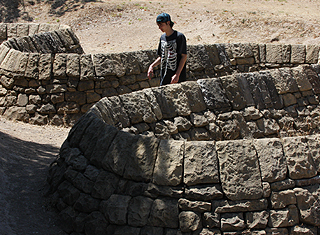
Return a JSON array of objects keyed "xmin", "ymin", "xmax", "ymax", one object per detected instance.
[{"xmin": 158, "ymin": 31, "xmax": 187, "ymax": 85}]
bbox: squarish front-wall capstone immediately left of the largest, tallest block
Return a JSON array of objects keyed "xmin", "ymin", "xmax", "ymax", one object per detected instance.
[{"xmin": 183, "ymin": 141, "xmax": 219, "ymax": 186}]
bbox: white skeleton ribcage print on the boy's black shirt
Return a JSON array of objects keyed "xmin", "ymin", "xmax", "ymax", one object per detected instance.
[{"xmin": 161, "ymin": 40, "xmax": 178, "ymax": 77}]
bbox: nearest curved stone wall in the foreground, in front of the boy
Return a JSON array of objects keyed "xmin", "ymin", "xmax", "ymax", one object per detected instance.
[{"xmin": 48, "ymin": 62, "xmax": 320, "ymax": 235}]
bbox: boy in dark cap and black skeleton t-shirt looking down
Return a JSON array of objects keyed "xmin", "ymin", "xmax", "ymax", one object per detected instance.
[{"xmin": 148, "ymin": 13, "xmax": 187, "ymax": 86}]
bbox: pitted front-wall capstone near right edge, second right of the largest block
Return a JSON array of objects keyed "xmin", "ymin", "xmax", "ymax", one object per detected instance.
[{"xmin": 283, "ymin": 137, "xmax": 317, "ymax": 179}]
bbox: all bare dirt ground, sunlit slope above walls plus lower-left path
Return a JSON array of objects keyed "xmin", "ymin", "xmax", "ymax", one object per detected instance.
[{"xmin": 0, "ymin": 0, "xmax": 320, "ymax": 235}]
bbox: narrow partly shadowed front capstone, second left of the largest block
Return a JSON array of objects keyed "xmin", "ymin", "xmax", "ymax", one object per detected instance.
[{"xmin": 153, "ymin": 140, "xmax": 184, "ymax": 186}]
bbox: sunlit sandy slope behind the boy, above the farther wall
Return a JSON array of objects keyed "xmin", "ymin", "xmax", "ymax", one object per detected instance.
[{"xmin": 19, "ymin": 0, "xmax": 320, "ymax": 53}]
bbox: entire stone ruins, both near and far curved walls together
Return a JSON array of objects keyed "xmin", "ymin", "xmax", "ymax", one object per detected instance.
[{"xmin": 0, "ymin": 24, "xmax": 320, "ymax": 235}]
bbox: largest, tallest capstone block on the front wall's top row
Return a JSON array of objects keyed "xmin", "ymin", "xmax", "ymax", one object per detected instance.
[{"xmin": 216, "ymin": 140, "xmax": 263, "ymax": 200}]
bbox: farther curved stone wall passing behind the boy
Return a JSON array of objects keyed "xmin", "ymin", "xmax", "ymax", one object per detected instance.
[{"xmin": 0, "ymin": 24, "xmax": 319, "ymax": 126}]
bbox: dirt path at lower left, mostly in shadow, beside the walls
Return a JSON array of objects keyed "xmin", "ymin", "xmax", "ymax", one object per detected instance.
[{"xmin": 0, "ymin": 118, "xmax": 69, "ymax": 235}]
